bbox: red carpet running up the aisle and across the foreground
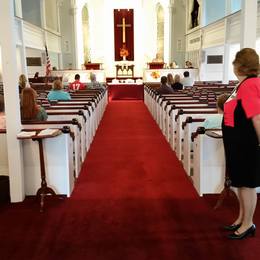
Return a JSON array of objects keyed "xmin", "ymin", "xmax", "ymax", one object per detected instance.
[{"xmin": 0, "ymin": 101, "xmax": 260, "ymax": 260}]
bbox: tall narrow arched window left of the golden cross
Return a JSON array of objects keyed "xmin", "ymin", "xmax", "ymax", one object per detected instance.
[{"xmin": 82, "ymin": 5, "xmax": 91, "ymax": 63}]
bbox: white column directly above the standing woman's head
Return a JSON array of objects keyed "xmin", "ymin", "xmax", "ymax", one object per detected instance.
[{"xmin": 240, "ymin": 0, "xmax": 257, "ymax": 49}]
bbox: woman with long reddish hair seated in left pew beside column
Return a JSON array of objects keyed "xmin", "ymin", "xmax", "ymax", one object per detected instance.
[{"xmin": 21, "ymin": 88, "xmax": 48, "ymax": 121}]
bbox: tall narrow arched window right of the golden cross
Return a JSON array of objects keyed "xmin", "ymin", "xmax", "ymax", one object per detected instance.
[{"xmin": 157, "ymin": 4, "xmax": 164, "ymax": 59}]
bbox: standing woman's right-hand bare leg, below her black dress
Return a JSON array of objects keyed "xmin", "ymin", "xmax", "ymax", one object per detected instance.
[{"xmin": 238, "ymin": 187, "xmax": 257, "ymax": 233}]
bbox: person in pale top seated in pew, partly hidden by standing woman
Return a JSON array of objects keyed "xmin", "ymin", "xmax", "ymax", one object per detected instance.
[{"xmin": 203, "ymin": 93, "xmax": 229, "ymax": 129}]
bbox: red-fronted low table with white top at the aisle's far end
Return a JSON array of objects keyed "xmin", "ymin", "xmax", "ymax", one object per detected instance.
[{"xmin": 108, "ymin": 83, "xmax": 144, "ymax": 101}]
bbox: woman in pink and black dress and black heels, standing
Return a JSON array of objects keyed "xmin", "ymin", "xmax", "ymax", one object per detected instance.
[{"xmin": 223, "ymin": 48, "xmax": 260, "ymax": 239}]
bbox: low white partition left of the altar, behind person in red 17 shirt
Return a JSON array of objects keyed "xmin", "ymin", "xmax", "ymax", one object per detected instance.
[{"xmin": 51, "ymin": 70, "xmax": 106, "ymax": 83}]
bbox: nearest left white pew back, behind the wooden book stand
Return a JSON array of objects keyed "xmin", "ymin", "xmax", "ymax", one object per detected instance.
[{"xmin": 18, "ymin": 128, "xmax": 75, "ymax": 197}]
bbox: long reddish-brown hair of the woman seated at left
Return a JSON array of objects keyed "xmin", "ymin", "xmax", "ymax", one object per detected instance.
[{"xmin": 21, "ymin": 88, "xmax": 40, "ymax": 120}]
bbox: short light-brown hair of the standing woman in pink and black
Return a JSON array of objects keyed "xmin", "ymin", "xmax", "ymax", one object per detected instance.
[{"xmin": 233, "ymin": 48, "xmax": 260, "ymax": 76}]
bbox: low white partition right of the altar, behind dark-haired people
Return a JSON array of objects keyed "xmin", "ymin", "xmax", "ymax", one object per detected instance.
[{"xmin": 143, "ymin": 68, "xmax": 199, "ymax": 82}]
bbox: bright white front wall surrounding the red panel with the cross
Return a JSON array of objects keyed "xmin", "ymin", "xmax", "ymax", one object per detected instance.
[{"xmin": 73, "ymin": 0, "xmax": 173, "ymax": 77}]
